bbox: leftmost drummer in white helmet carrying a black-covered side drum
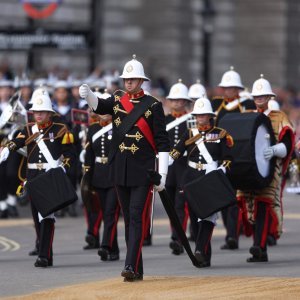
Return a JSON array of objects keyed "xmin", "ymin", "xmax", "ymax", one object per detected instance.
[{"xmin": 0, "ymin": 88, "xmax": 75, "ymax": 268}]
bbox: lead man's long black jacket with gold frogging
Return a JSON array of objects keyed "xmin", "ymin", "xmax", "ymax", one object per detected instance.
[{"xmin": 95, "ymin": 90, "xmax": 170, "ymax": 187}]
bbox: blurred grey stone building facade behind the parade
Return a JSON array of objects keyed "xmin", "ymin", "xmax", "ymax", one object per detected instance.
[{"xmin": 0, "ymin": 0, "xmax": 300, "ymax": 88}]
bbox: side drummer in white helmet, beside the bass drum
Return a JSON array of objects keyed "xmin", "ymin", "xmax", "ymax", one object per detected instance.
[{"xmin": 170, "ymin": 98, "xmax": 233, "ymax": 268}]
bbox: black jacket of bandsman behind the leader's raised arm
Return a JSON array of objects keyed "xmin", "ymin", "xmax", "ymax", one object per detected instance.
[{"xmin": 84, "ymin": 122, "xmax": 113, "ymax": 188}]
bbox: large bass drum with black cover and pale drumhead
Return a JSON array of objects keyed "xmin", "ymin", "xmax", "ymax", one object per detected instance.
[{"xmin": 219, "ymin": 112, "xmax": 276, "ymax": 190}]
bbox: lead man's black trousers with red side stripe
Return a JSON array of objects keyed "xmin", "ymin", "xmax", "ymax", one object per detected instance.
[{"xmin": 116, "ymin": 186, "xmax": 152, "ymax": 274}]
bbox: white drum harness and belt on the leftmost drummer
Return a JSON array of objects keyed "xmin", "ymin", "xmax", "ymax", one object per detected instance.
[{"xmin": 27, "ymin": 124, "xmax": 61, "ymax": 170}]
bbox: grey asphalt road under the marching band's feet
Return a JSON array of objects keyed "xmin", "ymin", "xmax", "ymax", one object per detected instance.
[{"xmin": 0, "ymin": 194, "xmax": 300, "ymax": 297}]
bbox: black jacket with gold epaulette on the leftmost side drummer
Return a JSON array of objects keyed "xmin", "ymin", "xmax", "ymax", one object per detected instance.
[{"xmin": 6, "ymin": 122, "xmax": 75, "ymax": 180}]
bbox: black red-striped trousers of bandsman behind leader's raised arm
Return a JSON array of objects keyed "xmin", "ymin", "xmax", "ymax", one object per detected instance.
[{"xmin": 97, "ymin": 187, "xmax": 120, "ymax": 252}]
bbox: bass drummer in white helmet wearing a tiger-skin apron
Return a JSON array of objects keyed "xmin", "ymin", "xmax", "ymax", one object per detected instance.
[{"xmin": 237, "ymin": 75, "xmax": 295, "ymax": 262}]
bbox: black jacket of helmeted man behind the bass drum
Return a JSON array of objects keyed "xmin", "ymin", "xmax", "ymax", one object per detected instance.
[{"xmin": 211, "ymin": 96, "xmax": 256, "ymax": 126}]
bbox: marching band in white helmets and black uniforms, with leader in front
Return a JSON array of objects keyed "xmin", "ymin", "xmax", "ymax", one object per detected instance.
[{"xmin": 0, "ymin": 56, "xmax": 294, "ymax": 281}]
